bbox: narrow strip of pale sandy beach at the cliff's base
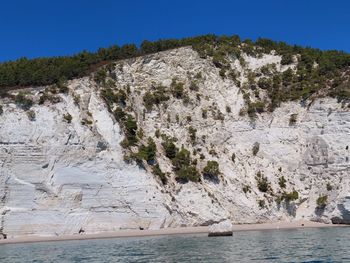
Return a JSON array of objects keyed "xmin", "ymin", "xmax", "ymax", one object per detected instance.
[{"xmin": 0, "ymin": 220, "xmax": 347, "ymax": 248}]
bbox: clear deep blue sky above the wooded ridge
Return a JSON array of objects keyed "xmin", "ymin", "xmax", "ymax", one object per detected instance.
[{"xmin": 0, "ymin": 0, "xmax": 350, "ymax": 61}]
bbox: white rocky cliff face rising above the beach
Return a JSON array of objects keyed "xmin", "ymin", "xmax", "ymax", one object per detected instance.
[{"xmin": 0, "ymin": 48, "xmax": 350, "ymax": 238}]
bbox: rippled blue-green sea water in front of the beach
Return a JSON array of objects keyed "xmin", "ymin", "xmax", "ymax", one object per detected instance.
[{"xmin": 0, "ymin": 228, "xmax": 350, "ymax": 263}]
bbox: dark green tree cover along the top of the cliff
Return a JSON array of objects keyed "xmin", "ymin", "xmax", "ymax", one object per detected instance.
[{"xmin": 0, "ymin": 35, "xmax": 350, "ymax": 111}]
